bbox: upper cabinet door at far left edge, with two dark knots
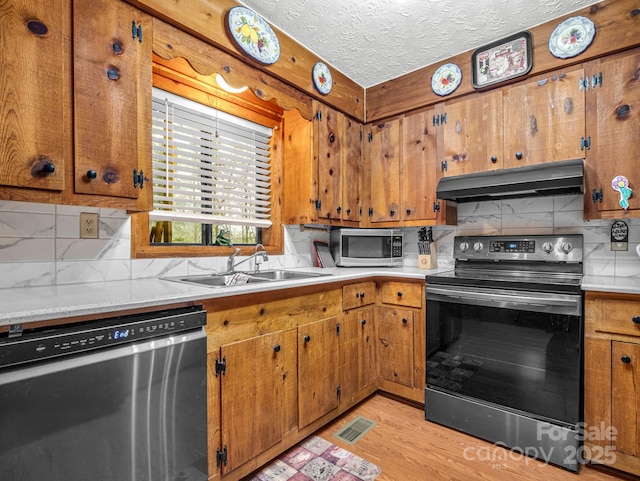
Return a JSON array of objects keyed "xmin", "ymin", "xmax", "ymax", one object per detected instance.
[{"xmin": 0, "ymin": 0, "xmax": 65, "ymax": 190}]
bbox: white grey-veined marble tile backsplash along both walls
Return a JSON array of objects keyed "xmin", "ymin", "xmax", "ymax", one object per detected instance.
[{"xmin": 0, "ymin": 195, "xmax": 640, "ymax": 288}]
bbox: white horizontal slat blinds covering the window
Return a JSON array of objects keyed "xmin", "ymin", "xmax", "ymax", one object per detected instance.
[{"xmin": 150, "ymin": 87, "xmax": 272, "ymax": 227}]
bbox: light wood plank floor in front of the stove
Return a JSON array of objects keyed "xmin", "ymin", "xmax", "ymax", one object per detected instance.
[{"xmin": 316, "ymin": 395, "xmax": 631, "ymax": 481}]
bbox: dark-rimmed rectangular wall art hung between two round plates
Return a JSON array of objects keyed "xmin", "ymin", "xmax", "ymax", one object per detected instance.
[{"xmin": 471, "ymin": 31, "xmax": 533, "ymax": 89}]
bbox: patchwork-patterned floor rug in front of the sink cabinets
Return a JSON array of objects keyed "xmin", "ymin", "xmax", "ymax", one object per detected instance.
[{"xmin": 250, "ymin": 436, "xmax": 381, "ymax": 481}]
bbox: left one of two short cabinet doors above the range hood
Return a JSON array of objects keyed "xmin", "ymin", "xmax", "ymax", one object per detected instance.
[{"xmin": 433, "ymin": 90, "xmax": 503, "ymax": 176}]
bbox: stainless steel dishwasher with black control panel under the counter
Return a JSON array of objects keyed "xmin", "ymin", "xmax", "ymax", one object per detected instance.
[{"xmin": 0, "ymin": 307, "xmax": 207, "ymax": 481}]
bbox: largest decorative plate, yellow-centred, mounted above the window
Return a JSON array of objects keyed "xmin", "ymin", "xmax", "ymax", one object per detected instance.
[{"xmin": 227, "ymin": 7, "xmax": 280, "ymax": 65}]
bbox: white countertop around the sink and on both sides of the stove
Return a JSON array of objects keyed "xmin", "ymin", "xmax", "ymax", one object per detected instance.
[{"xmin": 0, "ymin": 267, "xmax": 640, "ymax": 325}]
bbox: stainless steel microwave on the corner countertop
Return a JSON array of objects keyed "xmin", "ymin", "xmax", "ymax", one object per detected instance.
[{"xmin": 330, "ymin": 228, "xmax": 403, "ymax": 267}]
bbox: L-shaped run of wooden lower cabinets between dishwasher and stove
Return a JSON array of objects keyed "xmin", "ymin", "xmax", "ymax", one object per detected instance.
[{"xmin": 204, "ymin": 280, "xmax": 425, "ymax": 481}]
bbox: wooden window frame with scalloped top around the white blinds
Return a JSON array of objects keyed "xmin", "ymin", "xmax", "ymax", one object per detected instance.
[{"xmin": 131, "ymin": 54, "xmax": 284, "ymax": 259}]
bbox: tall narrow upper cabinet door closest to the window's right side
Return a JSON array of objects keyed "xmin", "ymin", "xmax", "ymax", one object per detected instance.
[{"xmin": 316, "ymin": 104, "xmax": 345, "ymax": 219}]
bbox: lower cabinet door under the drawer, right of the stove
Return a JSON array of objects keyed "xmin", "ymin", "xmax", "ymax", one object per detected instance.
[{"xmin": 611, "ymin": 341, "xmax": 640, "ymax": 456}]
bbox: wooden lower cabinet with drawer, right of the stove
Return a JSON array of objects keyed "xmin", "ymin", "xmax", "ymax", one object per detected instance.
[{"xmin": 584, "ymin": 292, "xmax": 640, "ymax": 476}]
